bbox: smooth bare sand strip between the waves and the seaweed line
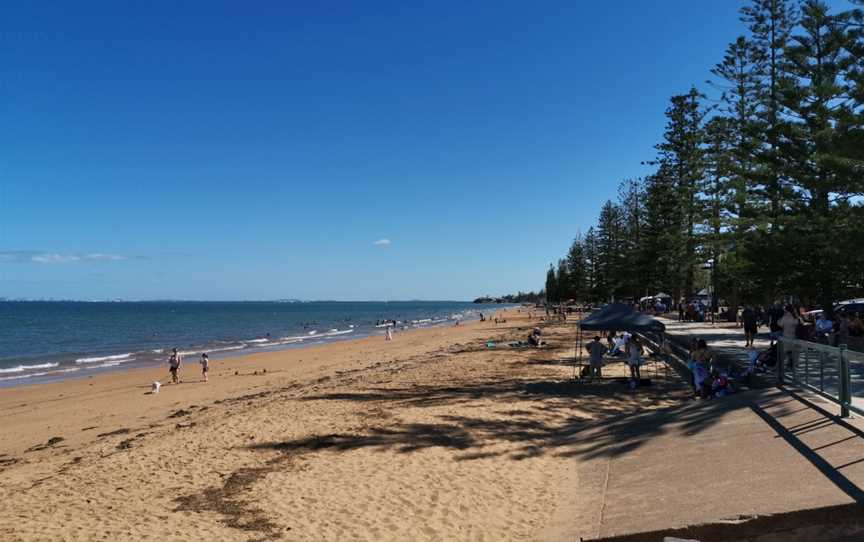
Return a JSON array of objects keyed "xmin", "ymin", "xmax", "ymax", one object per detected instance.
[{"xmin": 0, "ymin": 309, "xmax": 515, "ymax": 457}]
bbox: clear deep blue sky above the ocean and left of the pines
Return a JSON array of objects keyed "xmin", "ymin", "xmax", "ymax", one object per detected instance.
[{"xmin": 0, "ymin": 0, "xmax": 836, "ymax": 300}]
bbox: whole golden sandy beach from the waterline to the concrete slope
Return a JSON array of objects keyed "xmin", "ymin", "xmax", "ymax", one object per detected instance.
[{"xmin": 0, "ymin": 311, "xmax": 688, "ymax": 541}]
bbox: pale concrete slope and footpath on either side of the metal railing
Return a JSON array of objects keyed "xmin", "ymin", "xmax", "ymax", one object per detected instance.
[{"xmin": 557, "ymin": 322, "xmax": 864, "ymax": 542}]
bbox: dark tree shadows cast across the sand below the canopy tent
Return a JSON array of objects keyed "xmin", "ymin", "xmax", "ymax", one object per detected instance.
[{"xmin": 250, "ymin": 379, "xmax": 800, "ymax": 461}]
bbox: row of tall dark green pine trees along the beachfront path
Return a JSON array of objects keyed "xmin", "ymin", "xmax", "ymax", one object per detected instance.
[{"xmin": 546, "ymin": 0, "xmax": 864, "ymax": 318}]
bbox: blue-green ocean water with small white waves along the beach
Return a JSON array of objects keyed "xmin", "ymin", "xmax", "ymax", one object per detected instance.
[{"xmin": 0, "ymin": 301, "xmax": 506, "ymax": 387}]
